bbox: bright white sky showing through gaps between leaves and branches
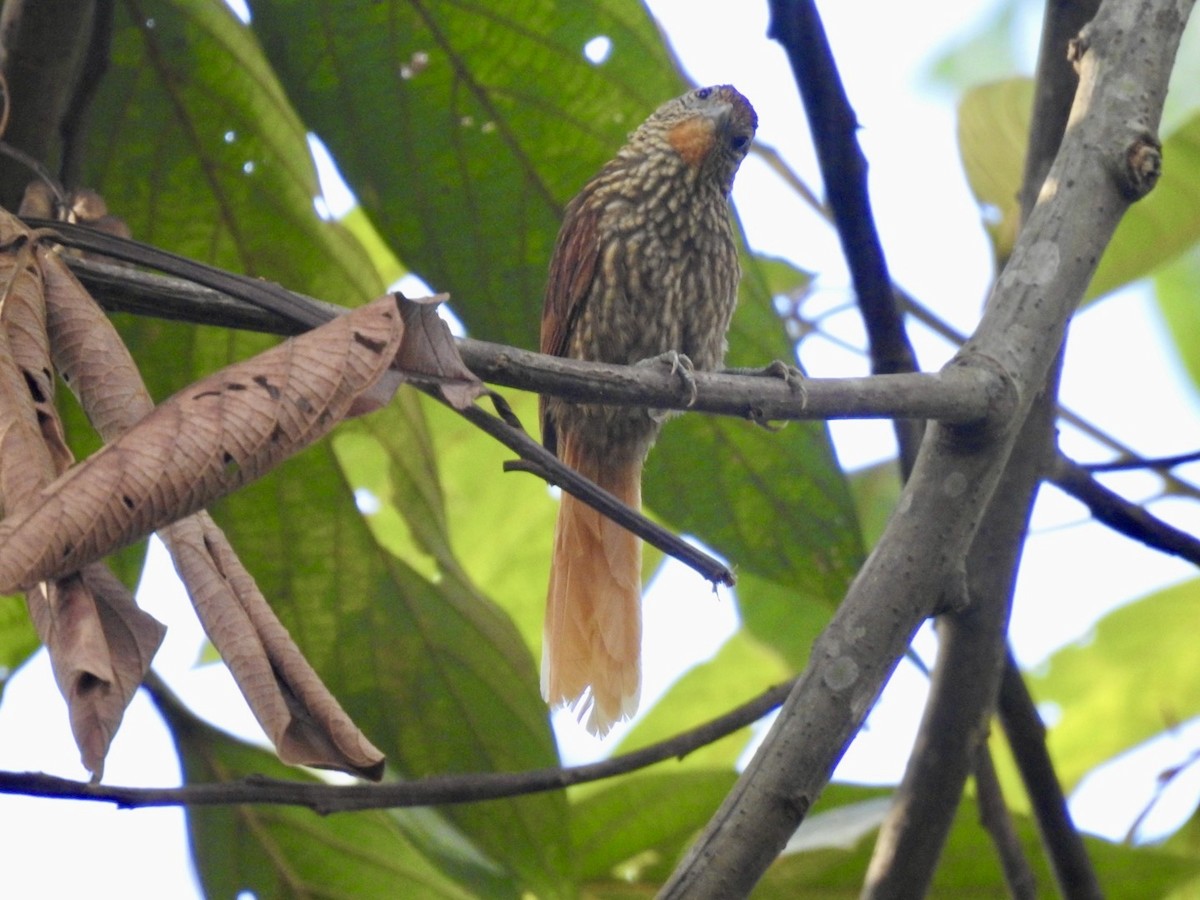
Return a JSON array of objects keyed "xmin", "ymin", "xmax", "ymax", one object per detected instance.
[{"xmin": 0, "ymin": 0, "xmax": 1200, "ymax": 899}]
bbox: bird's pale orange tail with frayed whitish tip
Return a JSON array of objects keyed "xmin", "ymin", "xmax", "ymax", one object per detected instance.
[{"xmin": 541, "ymin": 434, "xmax": 642, "ymax": 736}]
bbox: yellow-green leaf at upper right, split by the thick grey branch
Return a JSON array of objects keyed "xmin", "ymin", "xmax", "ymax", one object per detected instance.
[{"xmin": 959, "ymin": 78, "xmax": 1200, "ymax": 300}]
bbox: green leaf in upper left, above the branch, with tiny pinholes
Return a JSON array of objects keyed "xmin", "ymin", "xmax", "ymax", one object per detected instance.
[{"xmin": 85, "ymin": 0, "xmax": 383, "ymax": 304}]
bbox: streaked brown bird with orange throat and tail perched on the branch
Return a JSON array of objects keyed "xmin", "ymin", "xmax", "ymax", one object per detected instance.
[{"xmin": 541, "ymin": 85, "xmax": 758, "ymax": 734}]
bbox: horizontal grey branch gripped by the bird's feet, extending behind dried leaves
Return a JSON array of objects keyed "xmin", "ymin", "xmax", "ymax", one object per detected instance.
[{"xmin": 46, "ymin": 229, "xmax": 1000, "ymax": 425}]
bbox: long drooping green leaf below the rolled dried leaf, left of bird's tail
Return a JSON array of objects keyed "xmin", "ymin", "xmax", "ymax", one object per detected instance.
[{"xmin": 215, "ymin": 429, "xmax": 569, "ymax": 895}]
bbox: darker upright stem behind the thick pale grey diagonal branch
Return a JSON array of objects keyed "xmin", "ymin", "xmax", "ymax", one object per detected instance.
[{"xmin": 863, "ymin": 1, "xmax": 1097, "ymax": 898}]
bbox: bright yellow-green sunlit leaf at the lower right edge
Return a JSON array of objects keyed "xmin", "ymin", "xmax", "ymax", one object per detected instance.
[{"xmin": 1027, "ymin": 581, "xmax": 1200, "ymax": 790}]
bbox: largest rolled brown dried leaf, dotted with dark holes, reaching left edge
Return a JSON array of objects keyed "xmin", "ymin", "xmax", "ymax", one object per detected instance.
[{"xmin": 0, "ymin": 296, "xmax": 403, "ymax": 592}]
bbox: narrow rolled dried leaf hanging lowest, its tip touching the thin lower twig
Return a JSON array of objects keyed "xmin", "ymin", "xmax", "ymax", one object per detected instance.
[{"xmin": 161, "ymin": 512, "xmax": 384, "ymax": 781}]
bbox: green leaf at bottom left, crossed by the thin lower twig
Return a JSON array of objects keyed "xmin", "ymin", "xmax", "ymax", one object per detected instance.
[{"xmin": 158, "ymin": 686, "xmax": 484, "ymax": 898}]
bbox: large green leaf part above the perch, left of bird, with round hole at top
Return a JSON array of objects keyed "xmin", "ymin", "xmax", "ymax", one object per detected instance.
[{"xmin": 252, "ymin": 0, "xmax": 682, "ymax": 347}]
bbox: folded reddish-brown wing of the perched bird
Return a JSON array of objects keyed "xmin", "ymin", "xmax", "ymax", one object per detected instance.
[{"xmin": 538, "ymin": 185, "xmax": 600, "ymax": 452}]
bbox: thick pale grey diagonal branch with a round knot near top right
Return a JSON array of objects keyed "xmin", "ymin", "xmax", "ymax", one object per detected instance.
[{"xmin": 662, "ymin": 0, "xmax": 1192, "ymax": 898}]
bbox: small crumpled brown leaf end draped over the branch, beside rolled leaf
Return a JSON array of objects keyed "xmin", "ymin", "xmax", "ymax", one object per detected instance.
[{"xmin": 392, "ymin": 293, "xmax": 487, "ymax": 409}]
